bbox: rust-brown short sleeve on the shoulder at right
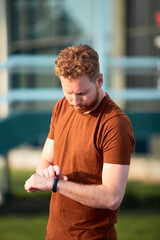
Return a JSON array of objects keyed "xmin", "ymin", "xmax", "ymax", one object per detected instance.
[{"xmin": 101, "ymin": 117, "xmax": 134, "ymax": 165}]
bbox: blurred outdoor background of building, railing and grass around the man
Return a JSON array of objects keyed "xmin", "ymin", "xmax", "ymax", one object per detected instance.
[{"xmin": 0, "ymin": 0, "xmax": 160, "ymax": 240}]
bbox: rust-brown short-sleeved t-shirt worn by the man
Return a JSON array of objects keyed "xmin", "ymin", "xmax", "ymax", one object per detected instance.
[{"xmin": 46, "ymin": 94, "xmax": 134, "ymax": 240}]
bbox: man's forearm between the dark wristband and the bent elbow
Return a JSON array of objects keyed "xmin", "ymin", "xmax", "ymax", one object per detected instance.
[{"xmin": 57, "ymin": 180, "xmax": 121, "ymax": 210}]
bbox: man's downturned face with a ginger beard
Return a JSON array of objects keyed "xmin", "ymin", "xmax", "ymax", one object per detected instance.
[{"xmin": 60, "ymin": 76, "xmax": 99, "ymax": 113}]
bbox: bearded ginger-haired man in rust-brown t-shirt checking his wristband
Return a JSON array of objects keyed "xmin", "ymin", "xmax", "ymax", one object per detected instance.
[{"xmin": 25, "ymin": 45, "xmax": 134, "ymax": 240}]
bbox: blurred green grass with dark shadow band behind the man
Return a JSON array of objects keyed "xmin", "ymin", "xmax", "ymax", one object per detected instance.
[{"xmin": 0, "ymin": 171, "xmax": 160, "ymax": 240}]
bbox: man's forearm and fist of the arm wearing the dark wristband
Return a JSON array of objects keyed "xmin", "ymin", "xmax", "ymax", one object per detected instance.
[{"xmin": 25, "ymin": 174, "xmax": 123, "ymax": 210}]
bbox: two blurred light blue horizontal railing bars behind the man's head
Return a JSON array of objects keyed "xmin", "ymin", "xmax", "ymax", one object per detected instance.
[{"xmin": 0, "ymin": 55, "xmax": 160, "ymax": 107}]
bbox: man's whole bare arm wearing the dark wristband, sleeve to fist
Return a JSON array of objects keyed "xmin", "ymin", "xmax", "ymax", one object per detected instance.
[{"xmin": 25, "ymin": 164, "xmax": 129, "ymax": 210}]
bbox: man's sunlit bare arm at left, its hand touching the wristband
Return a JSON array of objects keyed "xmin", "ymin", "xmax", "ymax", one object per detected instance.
[{"xmin": 36, "ymin": 138, "xmax": 54, "ymax": 175}]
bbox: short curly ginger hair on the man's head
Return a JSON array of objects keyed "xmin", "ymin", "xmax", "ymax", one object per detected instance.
[{"xmin": 55, "ymin": 44, "xmax": 99, "ymax": 81}]
